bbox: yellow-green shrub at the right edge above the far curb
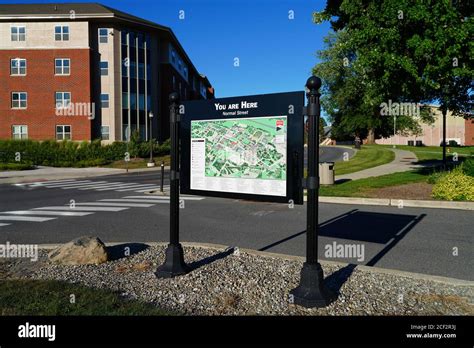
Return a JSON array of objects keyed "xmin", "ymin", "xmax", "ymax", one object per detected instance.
[{"xmin": 431, "ymin": 165, "xmax": 474, "ymax": 201}]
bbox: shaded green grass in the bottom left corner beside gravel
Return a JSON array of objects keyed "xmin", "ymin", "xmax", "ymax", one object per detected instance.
[{"xmin": 0, "ymin": 280, "xmax": 172, "ymax": 316}]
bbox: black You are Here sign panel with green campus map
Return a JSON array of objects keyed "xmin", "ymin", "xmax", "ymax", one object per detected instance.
[{"xmin": 181, "ymin": 92, "xmax": 304, "ymax": 204}]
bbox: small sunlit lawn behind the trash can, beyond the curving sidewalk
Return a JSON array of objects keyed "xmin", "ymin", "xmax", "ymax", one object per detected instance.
[{"xmin": 334, "ymin": 145, "xmax": 395, "ymax": 175}]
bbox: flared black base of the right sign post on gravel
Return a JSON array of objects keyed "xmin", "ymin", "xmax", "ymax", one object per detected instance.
[{"xmin": 290, "ymin": 262, "xmax": 336, "ymax": 308}]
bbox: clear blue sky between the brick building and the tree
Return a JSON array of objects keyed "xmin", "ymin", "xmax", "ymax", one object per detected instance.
[{"xmin": 0, "ymin": 0, "xmax": 329, "ymax": 98}]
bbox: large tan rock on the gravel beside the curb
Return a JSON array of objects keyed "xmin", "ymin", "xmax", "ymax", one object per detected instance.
[{"xmin": 48, "ymin": 236, "xmax": 108, "ymax": 265}]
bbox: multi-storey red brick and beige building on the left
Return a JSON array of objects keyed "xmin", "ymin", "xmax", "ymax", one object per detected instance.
[{"xmin": 0, "ymin": 3, "xmax": 214, "ymax": 142}]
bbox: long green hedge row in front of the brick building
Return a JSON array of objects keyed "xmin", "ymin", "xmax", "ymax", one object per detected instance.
[{"xmin": 0, "ymin": 139, "xmax": 170, "ymax": 167}]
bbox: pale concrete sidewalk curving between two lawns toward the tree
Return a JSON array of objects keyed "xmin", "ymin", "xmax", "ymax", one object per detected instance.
[{"xmin": 336, "ymin": 149, "xmax": 424, "ymax": 181}]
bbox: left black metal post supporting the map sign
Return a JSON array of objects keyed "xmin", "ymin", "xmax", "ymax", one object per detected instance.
[{"xmin": 155, "ymin": 92, "xmax": 189, "ymax": 278}]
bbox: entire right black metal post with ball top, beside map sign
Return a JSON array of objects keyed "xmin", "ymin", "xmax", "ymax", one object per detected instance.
[{"xmin": 290, "ymin": 76, "xmax": 334, "ymax": 308}]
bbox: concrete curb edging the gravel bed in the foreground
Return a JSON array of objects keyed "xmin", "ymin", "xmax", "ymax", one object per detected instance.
[{"xmin": 38, "ymin": 242, "xmax": 474, "ymax": 286}]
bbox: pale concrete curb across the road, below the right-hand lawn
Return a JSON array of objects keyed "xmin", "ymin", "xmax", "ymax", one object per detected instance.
[{"xmin": 303, "ymin": 196, "xmax": 474, "ymax": 210}]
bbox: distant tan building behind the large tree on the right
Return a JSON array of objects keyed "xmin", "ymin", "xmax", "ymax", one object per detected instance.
[{"xmin": 375, "ymin": 105, "xmax": 474, "ymax": 146}]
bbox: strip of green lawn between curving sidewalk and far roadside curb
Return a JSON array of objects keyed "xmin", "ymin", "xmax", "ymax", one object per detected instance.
[{"xmin": 319, "ymin": 171, "xmax": 429, "ymax": 197}]
